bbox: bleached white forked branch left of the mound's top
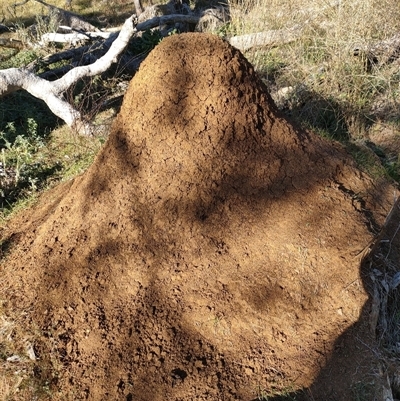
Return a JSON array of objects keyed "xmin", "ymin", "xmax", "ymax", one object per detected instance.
[{"xmin": 0, "ymin": 16, "xmax": 136, "ymax": 134}]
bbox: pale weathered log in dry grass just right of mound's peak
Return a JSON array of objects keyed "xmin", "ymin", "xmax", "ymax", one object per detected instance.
[{"xmin": 229, "ymin": 26, "xmax": 303, "ymax": 52}]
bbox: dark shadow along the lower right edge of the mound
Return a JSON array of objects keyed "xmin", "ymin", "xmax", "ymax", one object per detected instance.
[{"xmin": 258, "ymin": 227, "xmax": 400, "ymax": 401}]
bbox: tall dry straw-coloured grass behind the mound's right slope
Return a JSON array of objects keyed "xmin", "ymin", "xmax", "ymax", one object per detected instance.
[{"xmin": 227, "ymin": 0, "xmax": 400, "ymax": 143}]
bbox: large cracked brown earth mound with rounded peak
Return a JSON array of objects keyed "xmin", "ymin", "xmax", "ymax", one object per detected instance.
[{"xmin": 0, "ymin": 34, "xmax": 393, "ymax": 401}]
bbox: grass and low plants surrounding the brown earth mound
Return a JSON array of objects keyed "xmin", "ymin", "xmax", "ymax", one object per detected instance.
[{"xmin": 0, "ymin": 0, "xmax": 400, "ymax": 400}]
